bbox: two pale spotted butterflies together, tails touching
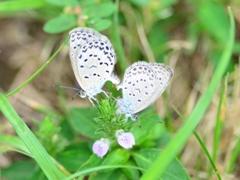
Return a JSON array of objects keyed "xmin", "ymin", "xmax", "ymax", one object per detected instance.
[{"xmin": 69, "ymin": 28, "xmax": 173, "ymax": 120}]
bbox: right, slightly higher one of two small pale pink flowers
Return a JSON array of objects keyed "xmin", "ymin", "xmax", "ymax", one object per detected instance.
[{"xmin": 116, "ymin": 129, "xmax": 135, "ymax": 149}]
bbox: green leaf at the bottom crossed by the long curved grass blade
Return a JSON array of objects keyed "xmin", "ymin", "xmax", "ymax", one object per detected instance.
[{"xmin": 133, "ymin": 149, "xmax": 190, "ymax": 180}]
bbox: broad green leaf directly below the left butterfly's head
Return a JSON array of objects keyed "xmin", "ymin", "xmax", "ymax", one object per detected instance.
[{"xmin": 70, "ymin": 108, "xmax": 99, "ymax": 139}]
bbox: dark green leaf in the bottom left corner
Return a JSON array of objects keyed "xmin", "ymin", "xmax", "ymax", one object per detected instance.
[{"xmin": 1, "ymin": 160, "xmax": 46, "ymax": 180}]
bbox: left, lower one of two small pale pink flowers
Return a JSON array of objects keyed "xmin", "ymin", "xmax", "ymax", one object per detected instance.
[{"xmin": 92, "ymin": 138, "xmax": 110, "ymax": 158}]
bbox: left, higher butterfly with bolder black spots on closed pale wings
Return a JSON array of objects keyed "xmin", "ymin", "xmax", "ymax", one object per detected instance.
[{"xmin": 69, "ymin": 28, "xmax": 120, "ymax": 104}]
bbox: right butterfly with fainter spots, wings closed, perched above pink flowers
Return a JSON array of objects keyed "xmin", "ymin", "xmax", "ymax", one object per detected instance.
[{"xmin": 117, "ymin": 61, "xmax": 173, "ymax": 120}]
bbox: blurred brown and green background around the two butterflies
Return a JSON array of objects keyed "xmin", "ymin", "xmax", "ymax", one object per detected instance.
[{"xmin": 0, "ymin": 0, "xmax": 240, "ymax": 180}]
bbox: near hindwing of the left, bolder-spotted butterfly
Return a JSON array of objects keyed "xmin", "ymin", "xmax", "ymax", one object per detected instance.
[{"xmin": 77, "ymin": 40, "xmax": 119, "ymax": 96}]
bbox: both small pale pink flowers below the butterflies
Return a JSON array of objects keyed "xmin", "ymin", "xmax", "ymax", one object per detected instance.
[{"xmin": 92, "ymin": 129, "xmax": 135, "ymax": 158}]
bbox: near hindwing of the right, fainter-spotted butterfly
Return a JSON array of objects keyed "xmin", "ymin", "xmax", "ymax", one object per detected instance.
[{"xmin": 118, "ymin": 61, "xmax": 156, "ymax": 115}]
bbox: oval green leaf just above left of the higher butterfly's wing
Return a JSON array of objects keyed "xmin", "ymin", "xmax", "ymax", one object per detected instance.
[{"xmin": 43, "ymin": 14, "xmax": 77, "ymax": 34}]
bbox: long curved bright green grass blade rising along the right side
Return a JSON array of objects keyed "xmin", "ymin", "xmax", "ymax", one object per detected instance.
[{"xmin": 141, "ymin": 8, "xmax": 235, "ymax": 180}]
